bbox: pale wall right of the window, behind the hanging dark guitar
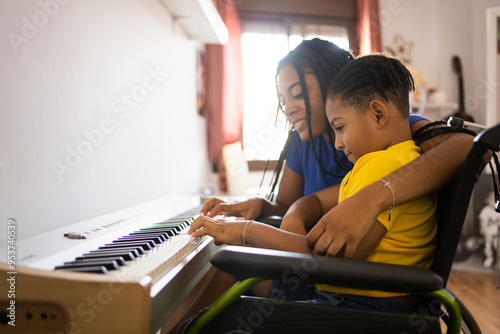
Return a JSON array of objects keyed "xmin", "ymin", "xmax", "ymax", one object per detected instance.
[{"xmin": 380, "ymin": 0, "xmax": 500, "ymax": 124}]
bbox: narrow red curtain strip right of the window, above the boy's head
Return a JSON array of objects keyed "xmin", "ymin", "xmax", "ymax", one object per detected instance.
[{"xmin": 357, "ymin": 0, "xmax": 382, "ymax": 55}]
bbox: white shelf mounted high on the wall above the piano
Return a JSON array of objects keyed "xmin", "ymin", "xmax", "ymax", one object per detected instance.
[{"xmin": 162, "ymin": 0, "xmax": 228, "ymax": 44}]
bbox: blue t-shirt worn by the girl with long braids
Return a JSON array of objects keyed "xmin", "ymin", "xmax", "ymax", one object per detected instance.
[{"xmin": 286, "ymin": 114, "xmax": 428, "ymax": 196}]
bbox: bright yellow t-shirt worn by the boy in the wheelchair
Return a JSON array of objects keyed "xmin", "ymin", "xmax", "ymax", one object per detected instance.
[{"xmin": 316, "ymin": 140, "xmax": 437, "ymax": 297}]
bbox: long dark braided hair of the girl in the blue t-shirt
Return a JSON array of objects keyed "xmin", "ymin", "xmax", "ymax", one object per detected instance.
[{"xmin": 266, "ymin": 38, "xmax": 354, "ymax": 201}]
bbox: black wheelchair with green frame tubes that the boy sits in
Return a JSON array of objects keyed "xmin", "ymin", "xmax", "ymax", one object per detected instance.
[{"xmin": 184, "ymin": 124, "xmax": 500, "ymax": 334}]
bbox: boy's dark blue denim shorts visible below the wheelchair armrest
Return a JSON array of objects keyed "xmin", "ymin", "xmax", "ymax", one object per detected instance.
[{"xmin": 268, "ymin": 280, "xmax": 417, "ymax": 313}]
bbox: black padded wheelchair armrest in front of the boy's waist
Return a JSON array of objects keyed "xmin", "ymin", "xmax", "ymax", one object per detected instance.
[{"xmin": 210, "ymin": 246, "xmax": 444, "ymax": 293}]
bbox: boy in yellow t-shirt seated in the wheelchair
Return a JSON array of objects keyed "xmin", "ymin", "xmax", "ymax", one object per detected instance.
[{"xmin": 185, "ymin": 55, "xmax": 437, "ymax": 312}]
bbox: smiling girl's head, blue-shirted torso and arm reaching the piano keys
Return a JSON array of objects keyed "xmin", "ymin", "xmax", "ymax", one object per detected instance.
[{"xmin": 201, "ymin": 39, "xmax": 353, "ymax": 219}]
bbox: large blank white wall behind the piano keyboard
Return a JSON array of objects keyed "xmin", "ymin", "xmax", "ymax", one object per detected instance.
[{"xmin": 0, "ymin": 0, "xmax": 209, "ymax": 238}]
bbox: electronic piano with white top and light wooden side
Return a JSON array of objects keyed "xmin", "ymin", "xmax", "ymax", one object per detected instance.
[{"xmin": 0, "ymin": 195, "xmax": 217, "ymax": 333}]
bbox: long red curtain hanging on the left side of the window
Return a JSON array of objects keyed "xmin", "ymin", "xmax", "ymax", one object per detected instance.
[{"xmin": 205, "ymin": 0, "xmax": 243, "ymax": 191}]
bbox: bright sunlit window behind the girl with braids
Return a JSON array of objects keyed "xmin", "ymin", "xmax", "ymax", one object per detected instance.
[{"xmin": 241, "ymin": 21, "xmax": 349, "ymax": 160}]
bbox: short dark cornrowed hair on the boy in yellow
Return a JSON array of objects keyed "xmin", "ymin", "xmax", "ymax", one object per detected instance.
[{"xmin": 328, "ymin": 54, "xmax": 415, "ymax": 118}]
